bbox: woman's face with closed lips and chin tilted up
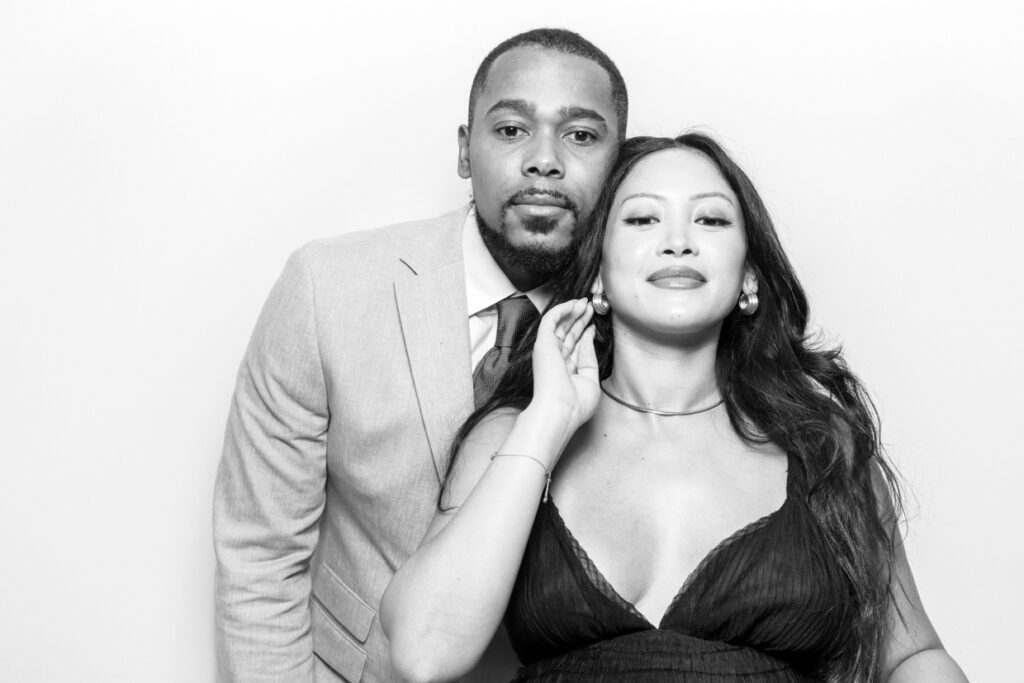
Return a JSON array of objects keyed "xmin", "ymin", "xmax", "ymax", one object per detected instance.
[{"xmin": 601, "ymin": 150, "xmax": 753, "ymax": 339}]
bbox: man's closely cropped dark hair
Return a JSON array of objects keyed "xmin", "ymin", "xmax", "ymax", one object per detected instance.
[{"xmin": 468, "ymin": 29, "xmax": 630, "ymax": 140}]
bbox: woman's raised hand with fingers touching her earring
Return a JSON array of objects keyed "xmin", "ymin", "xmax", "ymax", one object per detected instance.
[{"xmin": 530, "ymin": 299, "xmax": 601, "ymax": 434}]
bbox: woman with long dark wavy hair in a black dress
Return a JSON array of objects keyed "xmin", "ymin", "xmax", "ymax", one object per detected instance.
[{"xmin": 381, "ymin": 133, "xmax": 966, "ymax": 683}]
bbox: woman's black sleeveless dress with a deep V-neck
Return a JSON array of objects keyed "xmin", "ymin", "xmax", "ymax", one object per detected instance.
[{"xmin": 505, "ymin": 457, "xmax": 851, "ymax": 683}]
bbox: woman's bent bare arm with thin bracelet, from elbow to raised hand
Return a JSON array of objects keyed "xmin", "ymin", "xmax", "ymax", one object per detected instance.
[{"xmin": 380, "ymin": 299, "xmax": 601, "ymax": 681}]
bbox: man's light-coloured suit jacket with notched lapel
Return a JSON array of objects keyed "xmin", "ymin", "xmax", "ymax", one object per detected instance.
[{"xmin": 214, "ymin": 208, "xmax": 483, "ymax": 682}]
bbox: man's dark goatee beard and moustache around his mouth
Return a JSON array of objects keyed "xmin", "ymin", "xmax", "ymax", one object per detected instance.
[{"xmin": 476, "ymin": 189, "xmax": 580, "ymax": 276}]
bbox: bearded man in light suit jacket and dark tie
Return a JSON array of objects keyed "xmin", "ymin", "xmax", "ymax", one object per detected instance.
[{"xmin": 214, "ymin": 30, "xmax": 627, "ymax": 682}]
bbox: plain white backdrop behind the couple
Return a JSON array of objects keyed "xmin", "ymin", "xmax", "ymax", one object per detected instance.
[{"xmin": 0, "ymin": 0, "xmax": 1024, "ymax": 682}]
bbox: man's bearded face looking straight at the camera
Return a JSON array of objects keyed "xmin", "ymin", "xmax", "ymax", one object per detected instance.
[{"xmin": 459, "ymin": 46, "xmax": 618, "ymax": 286}]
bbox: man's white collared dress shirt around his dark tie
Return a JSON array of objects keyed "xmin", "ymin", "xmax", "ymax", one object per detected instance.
[{"xmin": 462, "ymin": 208, "xmax": 551, "ymax": 368}]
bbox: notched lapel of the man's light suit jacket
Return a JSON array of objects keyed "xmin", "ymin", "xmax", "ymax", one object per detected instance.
[{"xmin": 394, "ymin": 210, "xmax": 473, "ymax": 478}]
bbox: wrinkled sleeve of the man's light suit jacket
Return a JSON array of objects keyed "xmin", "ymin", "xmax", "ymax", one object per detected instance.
[{"xmin": 213, "ymin": 250, "xmax": 329, "ymax": 682}]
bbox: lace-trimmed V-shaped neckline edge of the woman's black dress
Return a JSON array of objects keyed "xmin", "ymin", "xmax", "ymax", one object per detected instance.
[{"xmin": 546, "ymin": 457, "xmax": 794, "ymax": 630}]
